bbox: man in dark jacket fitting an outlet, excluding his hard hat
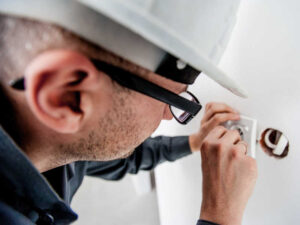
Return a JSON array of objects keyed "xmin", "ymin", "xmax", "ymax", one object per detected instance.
[{"xmin": 0, "ymin": 1, "xmax": 257, "ymax": 224}]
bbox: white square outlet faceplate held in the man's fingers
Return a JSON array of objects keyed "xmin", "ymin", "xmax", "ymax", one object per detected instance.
[{"xmin": 224, "ymin": 116, "xmax": 257, "ymax": 158}]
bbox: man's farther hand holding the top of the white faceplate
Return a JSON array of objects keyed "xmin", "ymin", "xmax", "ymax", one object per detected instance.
[{"xmin": 189, "ymin": 102, "xmax": 240, "ymax": 152}]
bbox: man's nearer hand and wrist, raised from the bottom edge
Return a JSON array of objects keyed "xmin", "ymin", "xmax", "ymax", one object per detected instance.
[{"xmin": 200, "ymin": 126, "xmax": 257, "ymax": 225}]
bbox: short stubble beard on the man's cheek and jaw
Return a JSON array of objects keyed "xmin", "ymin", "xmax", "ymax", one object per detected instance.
[{"xmin": 64, "ymin": 86, "xmax": 155, "ymax": 161}]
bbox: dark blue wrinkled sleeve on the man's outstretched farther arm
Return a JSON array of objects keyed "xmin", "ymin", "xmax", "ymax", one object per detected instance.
[{"xmin": 86, "ymin": 136, "xmax": 191, "ymax": 180}]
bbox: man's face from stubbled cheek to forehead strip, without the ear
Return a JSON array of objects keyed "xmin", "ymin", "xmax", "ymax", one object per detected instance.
[{"xmin": 78, "ymin": 69, "xmax": 187, "ymax": 160}]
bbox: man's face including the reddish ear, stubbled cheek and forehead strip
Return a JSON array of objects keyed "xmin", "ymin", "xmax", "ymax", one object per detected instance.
[{"xmin": 17, "ymin": 49, "xmax": 186, "ymax": 161}]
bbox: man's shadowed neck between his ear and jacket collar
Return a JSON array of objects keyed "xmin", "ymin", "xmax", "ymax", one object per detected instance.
[{"xmin": 0, "ymin": 90, "xmax": 72, "ymax": 173}]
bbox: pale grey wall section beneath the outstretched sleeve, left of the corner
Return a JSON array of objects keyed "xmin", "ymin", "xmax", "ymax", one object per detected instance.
[{"xmin": 72, "ymin": 175, "xmax": 159, "ymax": 225}]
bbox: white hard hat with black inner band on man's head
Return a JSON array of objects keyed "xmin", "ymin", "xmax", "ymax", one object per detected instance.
[{"xmin": 0, "ymin": 0, "xmax": 247, "ymax": 97}]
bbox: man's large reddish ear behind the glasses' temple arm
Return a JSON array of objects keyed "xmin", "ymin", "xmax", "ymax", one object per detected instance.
[{"xmin": 25, "ymin": 50, "xmax": 100, "ymax": 133}]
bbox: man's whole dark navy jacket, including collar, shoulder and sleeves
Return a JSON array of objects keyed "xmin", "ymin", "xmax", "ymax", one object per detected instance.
[{"xmin": 0, "ymin": 127, "xmax": 216, "ymax": 225}]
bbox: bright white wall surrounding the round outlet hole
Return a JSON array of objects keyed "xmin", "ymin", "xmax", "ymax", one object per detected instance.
[{"xmin": 156, "ymin": 0, "xmax": 300, "ymax": 225}]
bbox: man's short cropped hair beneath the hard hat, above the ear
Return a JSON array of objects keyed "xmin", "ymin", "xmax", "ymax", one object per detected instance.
[{"xmin": 0, "ymin": 13, "xmax": 149, "ymax": 85}]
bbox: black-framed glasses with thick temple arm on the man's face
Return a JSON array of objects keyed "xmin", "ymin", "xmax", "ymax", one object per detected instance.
[{"xmin": 10, "ymin": 59, "xmax": 202, "ymax": 124}]
